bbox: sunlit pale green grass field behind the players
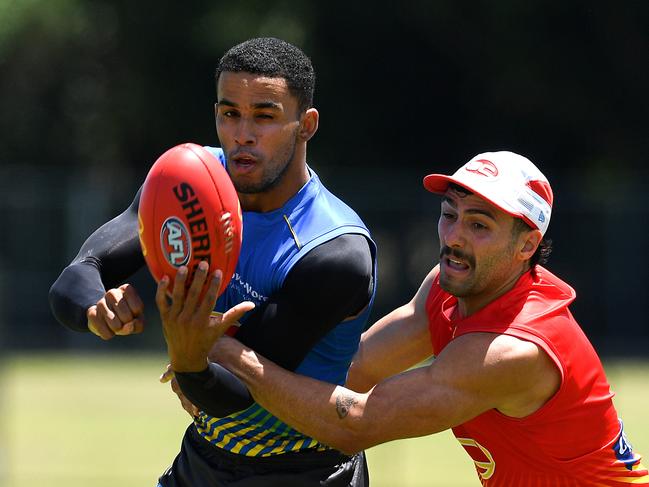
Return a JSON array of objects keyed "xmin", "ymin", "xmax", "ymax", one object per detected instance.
[{"xmin": 0, "ymin": 355, "xmax": 649, "ymax": 487}]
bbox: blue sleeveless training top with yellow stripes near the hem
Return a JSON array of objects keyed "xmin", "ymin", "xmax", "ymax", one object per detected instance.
[{"xmin": 195, "ymin": 147, "xmax": 376, "ymax": 456}]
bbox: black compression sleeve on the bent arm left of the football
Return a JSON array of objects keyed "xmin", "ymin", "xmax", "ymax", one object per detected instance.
[{"xmin": 49, "ymin": 188, "xmax": 144, "ymax": 331}]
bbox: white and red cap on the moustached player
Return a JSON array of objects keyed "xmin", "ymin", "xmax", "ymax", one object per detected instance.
[{"xmin": 424, "ymin": 151, "xmax": 552, "ymax": 235}]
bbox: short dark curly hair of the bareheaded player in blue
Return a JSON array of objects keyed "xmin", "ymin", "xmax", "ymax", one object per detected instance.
[{"xmin": 215, "ymin": 37, "xmax": 315, "ymax": 112}]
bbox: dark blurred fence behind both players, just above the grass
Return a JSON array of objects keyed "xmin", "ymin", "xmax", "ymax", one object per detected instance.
[{"xmin": 0, "ymin": 162, "xmax": 649, "ymax": 356}]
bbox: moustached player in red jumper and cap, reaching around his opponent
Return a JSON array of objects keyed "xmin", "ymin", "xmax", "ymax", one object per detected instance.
[{"xmin": 181, "ymin": 151, "xmax": 649, "ymax": 487}]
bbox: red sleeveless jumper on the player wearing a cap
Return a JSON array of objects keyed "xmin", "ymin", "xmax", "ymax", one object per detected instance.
[{"xmin": 426, "ymin": 266, "xmax": 649, "ymax": 487}]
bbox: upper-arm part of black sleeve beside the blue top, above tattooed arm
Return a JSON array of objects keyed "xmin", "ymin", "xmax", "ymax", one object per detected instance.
[{"xmin": 236, "ymin": 234, "xmax": 374, "ymax": 370}]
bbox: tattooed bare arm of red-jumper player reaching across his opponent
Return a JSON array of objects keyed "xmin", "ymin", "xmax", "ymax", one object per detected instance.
[{"xmin": 217, "ymin": 266, "xmax": 561, "ymax": 453}]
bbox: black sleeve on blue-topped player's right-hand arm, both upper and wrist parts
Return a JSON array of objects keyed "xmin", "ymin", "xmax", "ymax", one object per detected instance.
[{"xmin": 176, "ymin": 234, "xmax": 374, "ymax": 417}]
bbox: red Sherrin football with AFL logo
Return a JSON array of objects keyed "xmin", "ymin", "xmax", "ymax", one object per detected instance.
[{"xmin": 138, "ymin": 143, "xmax": 243, "ymax": 291}]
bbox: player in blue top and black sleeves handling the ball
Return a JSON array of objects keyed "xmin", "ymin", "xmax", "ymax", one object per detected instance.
[{"xmin": 50, "ymin": 38, "xmax": 376, "ymax": 487}]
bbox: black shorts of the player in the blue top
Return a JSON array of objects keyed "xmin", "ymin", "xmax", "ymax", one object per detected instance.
[{"xmin": 158, "ymin": 424, "xmax": 369, "ymax": 487}]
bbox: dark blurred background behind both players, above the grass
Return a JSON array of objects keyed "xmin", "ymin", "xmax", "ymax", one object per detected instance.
[{"xmin": 0, "ymin": 0, "xmax": 649, "ymax": 356}]
